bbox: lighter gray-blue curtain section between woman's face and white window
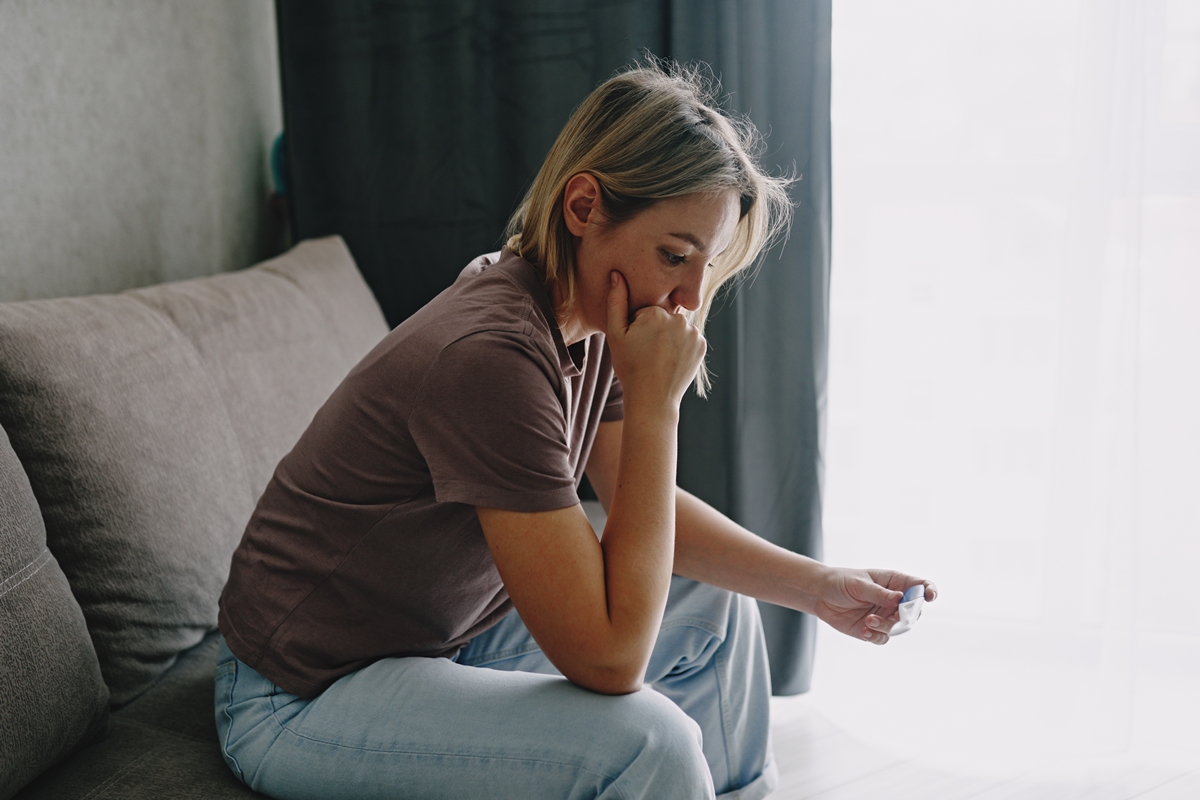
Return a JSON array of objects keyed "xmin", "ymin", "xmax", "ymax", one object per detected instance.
[{"xmin": 670, "ymin": 0, "xmax": 830, "ymax": 694}]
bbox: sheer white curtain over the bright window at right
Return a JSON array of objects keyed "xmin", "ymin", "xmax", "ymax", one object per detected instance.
[{"xmin": 810, "ymin": 0, "xmax": 1200, "ymax": 768}]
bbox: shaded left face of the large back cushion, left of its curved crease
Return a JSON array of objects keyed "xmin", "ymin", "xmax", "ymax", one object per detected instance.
[{"xmin": 0, "ymin": 295, "xmax": 253, "ymax": 705}]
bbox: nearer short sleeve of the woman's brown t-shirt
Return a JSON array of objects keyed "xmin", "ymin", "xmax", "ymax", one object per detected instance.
[{"xmin": 408, "ymin": 331, "xmax": 578, "ymax": 511}]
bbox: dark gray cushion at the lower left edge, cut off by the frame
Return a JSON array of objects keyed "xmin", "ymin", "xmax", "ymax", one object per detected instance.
[{"xmin": 0, "ymin": 429, "xmax": 108, "ymax": 798}]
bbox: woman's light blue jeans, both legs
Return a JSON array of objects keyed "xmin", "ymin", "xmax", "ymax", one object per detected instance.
[{"xmin": 216, "ymin": 577, "xmax": 776, "ymax": 800}]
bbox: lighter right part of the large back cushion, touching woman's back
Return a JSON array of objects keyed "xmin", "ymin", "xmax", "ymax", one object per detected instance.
[{"xmin": 135, "ymin": 237, "xmax": 388, "ymax": 501}]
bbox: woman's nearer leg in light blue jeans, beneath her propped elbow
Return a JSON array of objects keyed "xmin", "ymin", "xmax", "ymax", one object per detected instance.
[{"xmin": 216, "ymin": 649, "xmax": 713, "ymax": 799}]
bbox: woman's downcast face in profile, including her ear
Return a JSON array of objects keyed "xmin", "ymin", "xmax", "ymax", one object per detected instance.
[{"xmin": 563, "ymin": 173, "xmax": 740, "ymax": 344}]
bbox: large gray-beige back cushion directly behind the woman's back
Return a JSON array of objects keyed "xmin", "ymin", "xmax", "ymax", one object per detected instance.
[{"xmin": 0, "ymin": 239, "xmax": 386, "ymax": 706}]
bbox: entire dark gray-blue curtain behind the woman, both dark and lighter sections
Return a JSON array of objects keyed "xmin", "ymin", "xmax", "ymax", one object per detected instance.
[{"xmin": 276, "ymin": 0, "xmax": 830, "ymax": 694}]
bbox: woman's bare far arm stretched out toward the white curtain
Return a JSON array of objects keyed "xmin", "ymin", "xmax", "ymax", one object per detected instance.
[{"xmin": 587, "ymin": 422, "xmax": 937, "ymax": 644}]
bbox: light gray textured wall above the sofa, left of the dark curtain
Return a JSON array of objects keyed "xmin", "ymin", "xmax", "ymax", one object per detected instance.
[{"xmin": 0, "ymin": 0, "xmax": 281, "ymax": 300}]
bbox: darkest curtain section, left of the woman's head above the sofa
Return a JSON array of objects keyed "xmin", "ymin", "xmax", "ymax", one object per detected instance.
[{"xmin": 276, "ymin": 0, "xmax": 665, "ymax": 325}]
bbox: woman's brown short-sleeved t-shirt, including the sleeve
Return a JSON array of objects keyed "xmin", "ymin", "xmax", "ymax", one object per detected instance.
[{"xmin": 218, "ymin": 249, "xmax": 622, "ymax": 697}]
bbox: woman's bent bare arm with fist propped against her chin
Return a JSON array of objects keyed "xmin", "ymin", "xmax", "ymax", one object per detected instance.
[{"xmin": 476, "ymin": 273, "xmax": 704, "ymax": 694}]
